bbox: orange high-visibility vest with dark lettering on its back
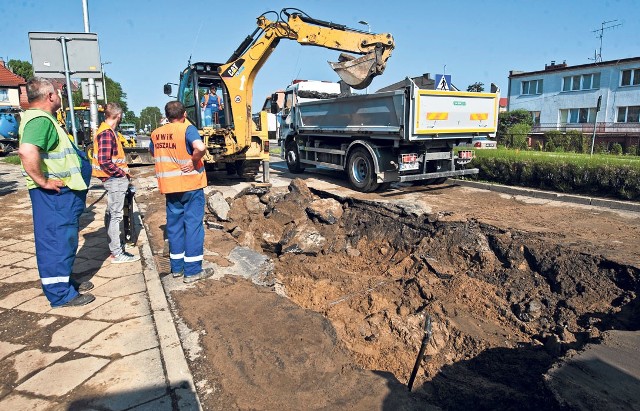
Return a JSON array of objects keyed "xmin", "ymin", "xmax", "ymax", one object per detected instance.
[{"xmin": 151, "ymin": 122, "xmax": 207, "ymax": 194}]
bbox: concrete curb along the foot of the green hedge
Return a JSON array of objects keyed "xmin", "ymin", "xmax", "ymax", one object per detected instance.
[{"xmin": 451, "ymin": 180, "xmax": 640, "ymax": 213}]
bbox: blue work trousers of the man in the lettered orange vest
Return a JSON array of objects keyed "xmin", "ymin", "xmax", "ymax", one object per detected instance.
[{"xmin": 166, "ymin": 189, "xmax": 204, "ymax": 277}]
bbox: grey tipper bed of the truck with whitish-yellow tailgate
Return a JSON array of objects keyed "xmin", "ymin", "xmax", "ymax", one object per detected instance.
[{"xmin": 294, "ymin": 83, "xmax": 499, "ymax": 141}]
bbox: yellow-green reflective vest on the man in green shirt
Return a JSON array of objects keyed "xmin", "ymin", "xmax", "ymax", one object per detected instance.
[{"xmin": 18, "ymin": 109, "xmax": 87, "ymax": 190}]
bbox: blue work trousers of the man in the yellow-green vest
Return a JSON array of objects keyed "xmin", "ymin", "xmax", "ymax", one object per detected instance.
[{"xmin": 29, "ymin": 187, "xmax": 87, "ymax": 307}]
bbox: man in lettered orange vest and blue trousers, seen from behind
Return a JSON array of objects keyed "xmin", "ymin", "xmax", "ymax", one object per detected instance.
[{"xmin": 150, "ymin": 101, "xmax": 213, "ymax": 283}]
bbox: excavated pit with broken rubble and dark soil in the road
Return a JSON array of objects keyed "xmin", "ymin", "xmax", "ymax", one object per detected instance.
[{"xmin": 216, "ymin": 180, "xmax": 640, "ymax": 409}]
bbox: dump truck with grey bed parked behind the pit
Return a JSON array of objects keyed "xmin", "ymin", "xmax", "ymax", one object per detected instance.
[{"xmin": 280, "ymin": 78, "xmax": 500, "ymax": 192}]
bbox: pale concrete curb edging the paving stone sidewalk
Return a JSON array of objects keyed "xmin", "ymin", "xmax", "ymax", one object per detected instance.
[{"xmin": 135, "ymin": 205, "xmax": 202, "ymax": 410}]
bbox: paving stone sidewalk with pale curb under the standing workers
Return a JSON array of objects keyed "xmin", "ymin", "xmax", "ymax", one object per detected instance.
[{"xmin": 0, "ymin": 163, "xmax": 200, "ymax": 410}]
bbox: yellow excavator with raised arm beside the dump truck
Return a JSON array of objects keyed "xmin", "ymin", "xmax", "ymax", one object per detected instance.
[{"xmin": 164, "ymin": 8, "xmax": 394, "ymax": 182}]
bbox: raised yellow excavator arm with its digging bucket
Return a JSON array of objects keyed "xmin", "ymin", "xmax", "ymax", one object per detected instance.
[{"xmin": 218, "ymin": 9, "xmax": 394, "ymax": 158}]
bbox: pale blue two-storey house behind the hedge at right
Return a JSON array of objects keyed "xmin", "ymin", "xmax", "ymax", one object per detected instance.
[{"xmin": 507, "ymin": 57, "xmax": 640, "ymax": 148}]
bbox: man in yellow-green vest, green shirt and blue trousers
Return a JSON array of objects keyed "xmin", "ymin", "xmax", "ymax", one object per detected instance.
[{"xmin": 18, "ymin": 77, "xmax": 95, "ymax": 308}]
